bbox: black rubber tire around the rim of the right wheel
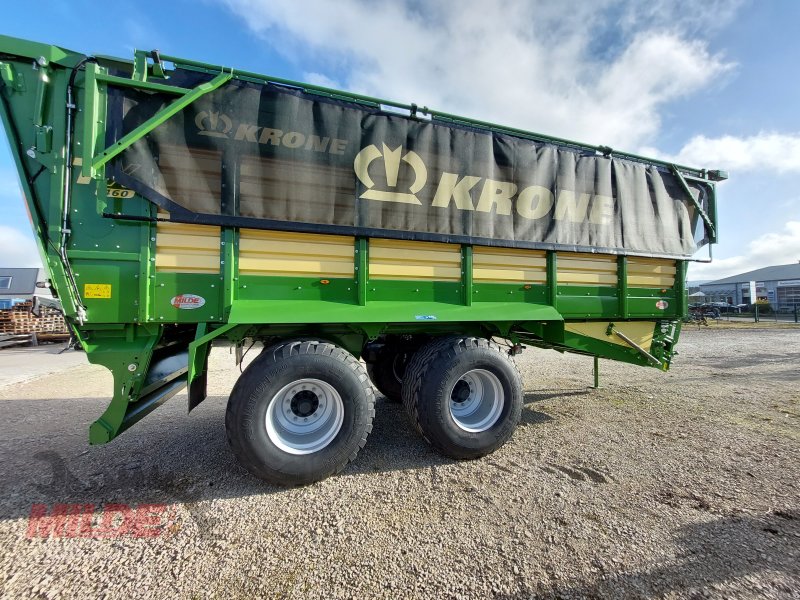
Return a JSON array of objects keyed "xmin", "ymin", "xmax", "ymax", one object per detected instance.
[{"xmin": 403, "ymin": 337, "xmax": 522, "ymax": 459}]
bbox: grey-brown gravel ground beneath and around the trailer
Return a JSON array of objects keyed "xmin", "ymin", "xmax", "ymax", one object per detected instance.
[{"xmin": 0, "ymin": 326, "xmax": 800, "ymax": 598}]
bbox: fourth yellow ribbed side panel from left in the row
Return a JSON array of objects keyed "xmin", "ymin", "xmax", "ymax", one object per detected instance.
[{"xmin": 472, "ymin": 246, "xmax": 547, "ymax": 283}]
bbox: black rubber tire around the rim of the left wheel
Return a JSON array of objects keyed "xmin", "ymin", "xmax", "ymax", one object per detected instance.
[{"xmin": 225, "ymin": 340, "xmax": 375, "ymax": 486}]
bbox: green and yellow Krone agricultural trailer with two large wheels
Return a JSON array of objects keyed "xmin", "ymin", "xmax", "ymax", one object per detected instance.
[{"xmin": 0, "ymin": 36, "xmax": 726, "ymax": 485}]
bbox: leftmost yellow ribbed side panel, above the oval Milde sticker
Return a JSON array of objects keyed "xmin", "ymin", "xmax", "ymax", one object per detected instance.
[{"xmin": 156, "ymin": 213, "xmax": 220, "ymax": 273}]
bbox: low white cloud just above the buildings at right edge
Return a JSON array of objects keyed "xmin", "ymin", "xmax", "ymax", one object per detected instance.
[{"xmin": 689, "ymin": 221, "xmax": 800, "ymax": 280}]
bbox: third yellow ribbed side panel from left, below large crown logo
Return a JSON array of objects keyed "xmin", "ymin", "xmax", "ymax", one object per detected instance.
[{"xmin": 369, "ymin": 238, "xmax": 461, "ymax": 281}]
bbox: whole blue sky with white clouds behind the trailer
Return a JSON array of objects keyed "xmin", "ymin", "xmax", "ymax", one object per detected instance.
[{"xmin": 0, "ymin": 0, "xmax": 800, "ymax": 280}]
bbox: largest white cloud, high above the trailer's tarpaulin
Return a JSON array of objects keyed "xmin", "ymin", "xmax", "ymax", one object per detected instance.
[{"xmin": 220, "ymin": 0, "xmax": 738, "ymax": 149}]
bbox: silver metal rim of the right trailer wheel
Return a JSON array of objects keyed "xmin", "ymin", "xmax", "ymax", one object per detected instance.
[{"xmin": 450, "ymin": 369, "xmax": 505, "ymax": 433}]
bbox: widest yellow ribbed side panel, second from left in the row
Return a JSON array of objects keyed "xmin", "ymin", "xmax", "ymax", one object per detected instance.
[{"xmin": 239, "ymin": 229, "xmax": 355, "ymax": 277}]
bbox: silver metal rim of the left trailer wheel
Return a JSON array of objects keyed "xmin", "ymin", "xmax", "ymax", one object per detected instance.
[{"xmin": 266, "ymin": 379, "xmax": 344, "ymax": 454}]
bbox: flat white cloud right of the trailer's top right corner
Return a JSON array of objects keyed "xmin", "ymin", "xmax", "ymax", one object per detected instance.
[{"xmin": 642, "ymin": 132, "xmax": 800, "ymax": 173}]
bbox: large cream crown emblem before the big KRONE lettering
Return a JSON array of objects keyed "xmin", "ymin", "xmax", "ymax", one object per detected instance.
[{"xmin": 353, "ymin": 144, "xmax": 428, "ymax": 205}]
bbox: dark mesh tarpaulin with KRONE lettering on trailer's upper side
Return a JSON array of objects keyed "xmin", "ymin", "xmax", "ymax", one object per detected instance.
[{"xmin": 107, "ymin": 76, "xmax": 712, "ymax": 257}]
